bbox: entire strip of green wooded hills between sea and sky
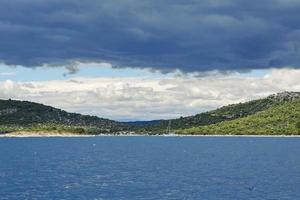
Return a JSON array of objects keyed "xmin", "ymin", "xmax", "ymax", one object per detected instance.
[{"xmin": 0, "ymin": 92, "xmax": 300, "ymax": 135}]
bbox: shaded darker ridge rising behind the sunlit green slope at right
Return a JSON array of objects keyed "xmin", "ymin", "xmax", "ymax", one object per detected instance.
[{"xmin": 141, "ymin": 92, "xmax": 300, "ymax": 133}]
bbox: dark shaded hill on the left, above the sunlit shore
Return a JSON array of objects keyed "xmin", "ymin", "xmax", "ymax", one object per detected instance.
[{"xmin": 0, "ymin": 100, "xmax": 129, "ymax": 133}]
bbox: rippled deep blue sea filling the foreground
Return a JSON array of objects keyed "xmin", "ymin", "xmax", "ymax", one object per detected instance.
[{"xmin": 0, "ymin": 137, "xmax": 300, "ymax": 200}]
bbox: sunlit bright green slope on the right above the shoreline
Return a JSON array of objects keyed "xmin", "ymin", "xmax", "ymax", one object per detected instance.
[{"xmin": 177, "ymin": 100, "xmax": 300, "ymax": 135}]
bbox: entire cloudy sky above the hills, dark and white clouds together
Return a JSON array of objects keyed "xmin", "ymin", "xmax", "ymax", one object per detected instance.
[{"xmin": 0, "ymin": 0, "xmax": 300, "ymax": 121}]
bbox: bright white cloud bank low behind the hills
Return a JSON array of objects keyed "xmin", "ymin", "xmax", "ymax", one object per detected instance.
[{"xmin": 0, "ymin": 69, "xmax": 300, "ymax": 120}]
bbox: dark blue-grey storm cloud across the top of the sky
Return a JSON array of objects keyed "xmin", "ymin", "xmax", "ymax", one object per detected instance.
[{"xmin": 0, "ymin": 0, "xmax": 300, "ymax": 72}]
